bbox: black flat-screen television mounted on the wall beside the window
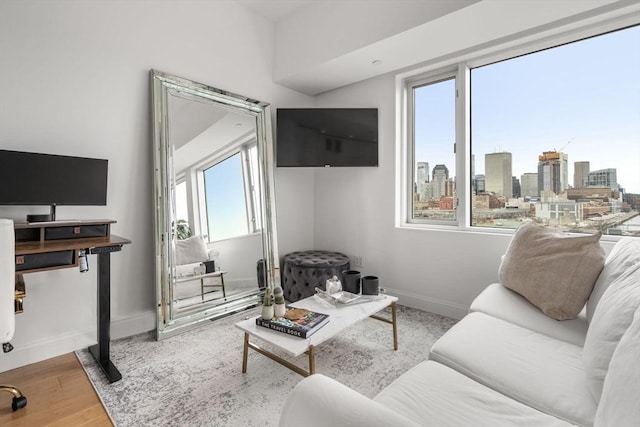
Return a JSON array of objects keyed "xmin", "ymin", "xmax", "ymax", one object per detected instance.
[{"xmin": 276, "ymin": 108, "xmax": 378, "ymax": 167}]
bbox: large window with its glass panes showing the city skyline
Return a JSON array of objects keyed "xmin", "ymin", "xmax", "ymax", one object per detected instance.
[{"xmin": 406, "ymin": 22, "xmax": 640, "ymax": 236}]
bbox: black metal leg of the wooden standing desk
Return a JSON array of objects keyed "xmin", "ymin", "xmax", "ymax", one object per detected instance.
[{"xmin": 89, "ymin": 252, "xmax": 122, "ymax": 383}]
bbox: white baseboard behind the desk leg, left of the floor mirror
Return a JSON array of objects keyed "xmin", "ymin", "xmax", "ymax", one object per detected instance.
[{"xmin": 0, "ymin": 311, "xmax": 156, "ymax": 372}]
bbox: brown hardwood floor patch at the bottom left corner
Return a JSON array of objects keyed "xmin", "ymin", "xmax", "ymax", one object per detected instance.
[{"xmin": 0, "ymin": 353, "xmax": 112, "ymax": 427}]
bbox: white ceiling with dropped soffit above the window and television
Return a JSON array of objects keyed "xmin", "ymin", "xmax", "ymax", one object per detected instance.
[{"xmin": 235, "ymin": 0, "xmax": 640, "ymax": 95}]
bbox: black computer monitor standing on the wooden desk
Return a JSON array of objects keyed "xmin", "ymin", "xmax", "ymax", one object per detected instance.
[{"xmin": 0, "ymin": 150, "xmax": 108, "ymax": 206}]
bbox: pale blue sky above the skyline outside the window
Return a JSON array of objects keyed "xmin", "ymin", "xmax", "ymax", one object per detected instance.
[{"xmin": 416, "ymin": 26, "xmax": 640, "ymax": 193}]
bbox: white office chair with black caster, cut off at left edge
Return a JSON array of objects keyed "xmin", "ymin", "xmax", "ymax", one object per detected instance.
[{"xmin": 0, "ymin": 219, "xmax": 27, "ymax": 411}]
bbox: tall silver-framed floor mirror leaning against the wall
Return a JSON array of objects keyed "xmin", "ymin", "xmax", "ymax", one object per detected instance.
[{"xmin": 151, "ymin": 70, "xmax": 279, "ymax": 339}]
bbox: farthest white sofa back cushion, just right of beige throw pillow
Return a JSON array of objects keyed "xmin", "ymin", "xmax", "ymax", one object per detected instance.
[{"xmin": 587, "ymin": 237, "xmax": 640, "ymax": 323}]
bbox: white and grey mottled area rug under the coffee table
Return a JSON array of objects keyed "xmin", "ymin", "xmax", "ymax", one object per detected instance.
[{"xmin": 77, "ymin": 306, "xmax": 455, "ymax": 427}]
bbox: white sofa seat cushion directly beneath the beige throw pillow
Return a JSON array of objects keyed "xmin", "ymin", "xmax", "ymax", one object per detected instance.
[{"xmin": 469, "ymin": 283, "xmax": 589, "ymax": 346}]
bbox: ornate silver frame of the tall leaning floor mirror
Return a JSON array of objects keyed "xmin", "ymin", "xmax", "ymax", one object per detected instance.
[{"xmin": 150, "ymin": 70, "xmax": 280, "ymax": 340}]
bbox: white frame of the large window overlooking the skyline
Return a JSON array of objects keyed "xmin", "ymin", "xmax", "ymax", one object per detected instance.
[{"xmin": 396, "ymin": 12, "xmax": 640, "ymax": 241}]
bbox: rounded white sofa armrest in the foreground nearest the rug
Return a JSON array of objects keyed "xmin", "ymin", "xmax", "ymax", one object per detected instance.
[{"xmin": 279, "ymin": 374, "xmax": 418, "ymax": 427}]
